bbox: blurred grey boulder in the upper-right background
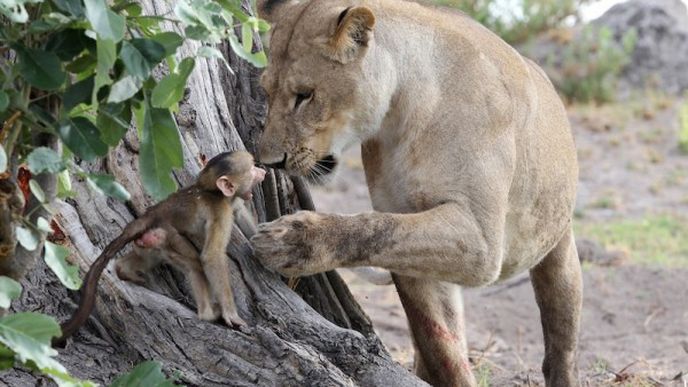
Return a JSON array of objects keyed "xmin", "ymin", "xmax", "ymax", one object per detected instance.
[{"xmin": 592, "ymin": 0, "xmax": 688, "ymax": 93}]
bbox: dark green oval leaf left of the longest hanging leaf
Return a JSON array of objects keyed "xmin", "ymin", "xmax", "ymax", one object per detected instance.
[{"xmin": 58, "ymin": 117, "xmax": 108, "ymax": 161}]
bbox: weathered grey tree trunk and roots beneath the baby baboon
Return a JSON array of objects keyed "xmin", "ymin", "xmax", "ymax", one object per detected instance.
[{"xmin": 0, "ymin": 0, "xmax": 424, "ymax": 386}]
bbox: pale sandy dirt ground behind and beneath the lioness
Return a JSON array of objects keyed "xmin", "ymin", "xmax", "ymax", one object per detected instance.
[{"xmin": 313, "ymin": 99, "xmax": 688, "ymax": 386}]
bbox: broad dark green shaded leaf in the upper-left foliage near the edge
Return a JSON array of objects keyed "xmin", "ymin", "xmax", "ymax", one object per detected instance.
[{"xmin": 15, "ymin": 46, "xmax": 67, "ymax": 90}]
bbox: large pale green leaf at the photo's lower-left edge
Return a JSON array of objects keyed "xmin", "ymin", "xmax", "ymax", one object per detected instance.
[{"xmin": 0, "ymin": 312, "xmax": 66, "ymax": 372}]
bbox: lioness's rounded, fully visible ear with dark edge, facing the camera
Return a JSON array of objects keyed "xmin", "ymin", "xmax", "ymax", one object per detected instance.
[{"xmin": 328, "ymin": 7, "xmax": 375, "ymax": 63}]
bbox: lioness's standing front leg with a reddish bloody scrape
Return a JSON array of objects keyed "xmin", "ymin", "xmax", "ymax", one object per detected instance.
[{"xmin": 392, "ymin": 274, "xmax": 476, "ymax": 387}]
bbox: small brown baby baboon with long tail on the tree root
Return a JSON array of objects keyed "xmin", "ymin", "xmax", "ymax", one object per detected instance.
[{"xmin": 57, "ymin": 151, "xmax": 265, "ymax": 342}]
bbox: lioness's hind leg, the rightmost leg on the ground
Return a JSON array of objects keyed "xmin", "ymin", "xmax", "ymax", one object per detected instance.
[{"xmin": 530, "ymin": 231, "xmax": 583, "ymax": 387}]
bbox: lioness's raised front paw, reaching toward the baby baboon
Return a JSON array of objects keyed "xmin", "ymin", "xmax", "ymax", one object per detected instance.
[{"xmin": 251, "ymin": 211, "xmax": 333, "ymax": 277}]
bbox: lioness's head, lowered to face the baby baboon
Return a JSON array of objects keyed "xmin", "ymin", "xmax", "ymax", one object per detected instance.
[{"xmin": 258, "ymin": 0, "xmax": 375, "ymax": 181}]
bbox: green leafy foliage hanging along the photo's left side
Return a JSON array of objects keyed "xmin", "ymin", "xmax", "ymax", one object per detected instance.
[{"xmin": 0, "ymin": 0, "xmax": 269, "ymax": 386}]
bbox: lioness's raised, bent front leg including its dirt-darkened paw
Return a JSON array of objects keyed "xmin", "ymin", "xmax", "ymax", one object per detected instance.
[{"xmin": 251, "ymin": 203, "xmax": 503, "ymax": 286}]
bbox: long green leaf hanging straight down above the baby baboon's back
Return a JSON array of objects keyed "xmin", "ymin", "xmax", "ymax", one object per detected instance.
[{"xmin": 139, "ymin": 104, "xmax": 184, "ymax": 200}]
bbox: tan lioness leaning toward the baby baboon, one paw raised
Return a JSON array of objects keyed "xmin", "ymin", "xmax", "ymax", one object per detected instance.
[{"xmin": 252, "ymin": 0, "xmax": 582, "ymax": 386}]
